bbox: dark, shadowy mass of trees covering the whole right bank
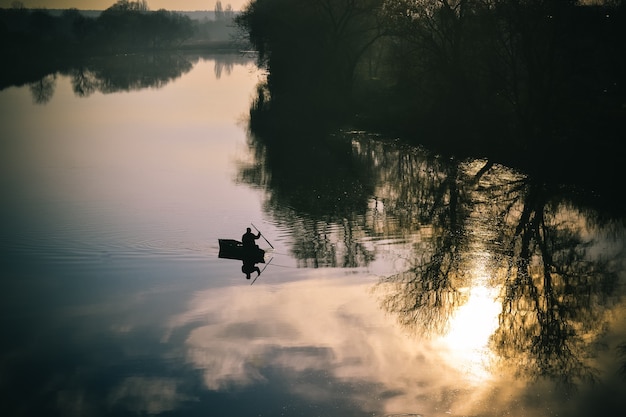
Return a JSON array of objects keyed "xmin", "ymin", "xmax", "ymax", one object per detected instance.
[{"xmin": 236, "ymin": 0, "xmax": 626, "ymax": 182}]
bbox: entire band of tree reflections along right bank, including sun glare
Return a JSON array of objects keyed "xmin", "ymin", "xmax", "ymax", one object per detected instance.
[{"xmin": 239, "ymin": 129, "xmax": 626, "ymax": 388}]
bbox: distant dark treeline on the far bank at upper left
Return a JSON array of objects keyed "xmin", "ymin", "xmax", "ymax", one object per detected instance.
[{"xmin": 0, "ymin": 0, "xmax": 239, "ymax": 59}]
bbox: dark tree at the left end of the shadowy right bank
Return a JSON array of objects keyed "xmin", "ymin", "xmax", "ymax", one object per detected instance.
[{"xmin": 235, "ymin": 0, "xmax": 384, "ymax": 115}]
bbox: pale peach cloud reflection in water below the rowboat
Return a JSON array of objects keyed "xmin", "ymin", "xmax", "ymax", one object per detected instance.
[{"xmin": 170, "ymin": 271, "xmax": 508, "ymax": 414}]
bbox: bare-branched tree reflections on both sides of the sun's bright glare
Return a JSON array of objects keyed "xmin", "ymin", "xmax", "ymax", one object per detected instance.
[{"xmin": 370, "ymin": 145, "xmax": 618, "ymax": 387}]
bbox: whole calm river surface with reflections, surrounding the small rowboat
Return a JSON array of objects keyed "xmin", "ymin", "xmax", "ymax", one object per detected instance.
[{"xmin": 0, "ymin": 55, "xmax": 626, "ymax": 417}]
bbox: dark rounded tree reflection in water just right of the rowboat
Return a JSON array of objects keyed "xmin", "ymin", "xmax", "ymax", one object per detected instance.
[{"xmin": 238, "ymin": 128, "xmax": 375, "ymax": 268}]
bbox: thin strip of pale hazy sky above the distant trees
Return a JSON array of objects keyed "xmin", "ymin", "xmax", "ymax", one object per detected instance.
[{"xmin": 0, "ymin": 0, "xmax": 250, "ymax": 10}]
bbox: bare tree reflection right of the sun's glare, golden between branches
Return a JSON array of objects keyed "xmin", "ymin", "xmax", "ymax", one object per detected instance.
[{"xmin": 493, "ymin": 181, "xmax": 618, "ymax": 386}]
